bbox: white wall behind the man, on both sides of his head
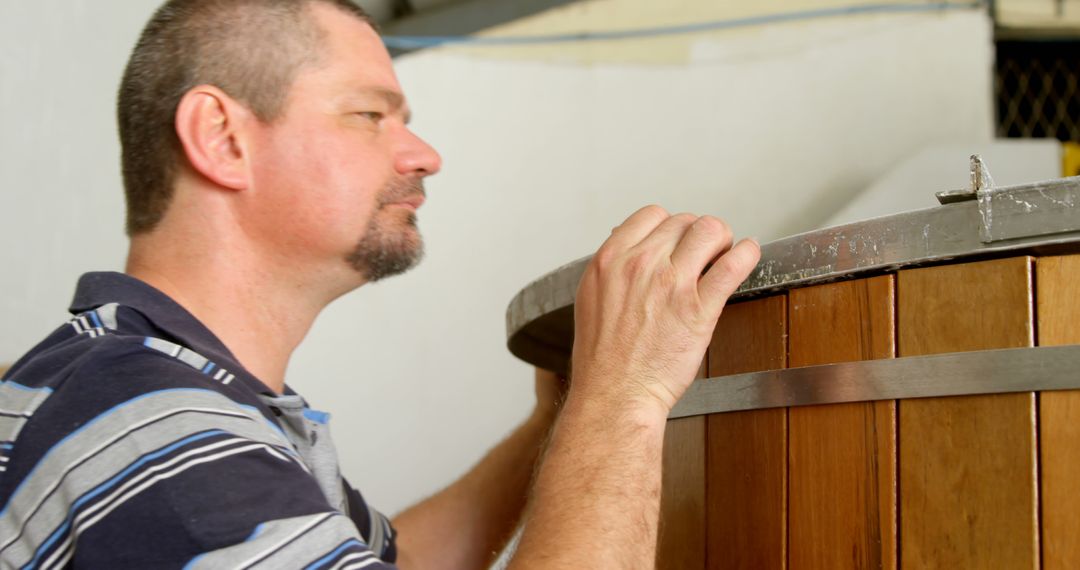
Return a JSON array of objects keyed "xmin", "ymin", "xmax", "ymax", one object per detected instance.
[{"xmin": 0, "ymin": 0, "xmax": 991, "ymax": 512}]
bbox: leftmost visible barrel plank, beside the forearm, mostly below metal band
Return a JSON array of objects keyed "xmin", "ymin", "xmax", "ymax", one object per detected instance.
[{"xmin": 656, "ymin": 355, "xmax": 708, "ymax": 570}]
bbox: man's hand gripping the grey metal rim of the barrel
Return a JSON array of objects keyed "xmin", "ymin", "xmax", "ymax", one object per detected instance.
[{"xmin": 571, "ymin": 206, "xmax": 760, "ymax": 416}]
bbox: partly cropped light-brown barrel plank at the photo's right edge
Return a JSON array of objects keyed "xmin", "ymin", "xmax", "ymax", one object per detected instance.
[{"xmin": 1035, "ymin": 255, "xmax": 1080, "ymax": 570}]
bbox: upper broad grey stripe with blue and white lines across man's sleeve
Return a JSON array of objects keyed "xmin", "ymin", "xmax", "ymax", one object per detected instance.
[{"xmin": 0, "ymin": 389, "xmax": 306, "ymax": 568}]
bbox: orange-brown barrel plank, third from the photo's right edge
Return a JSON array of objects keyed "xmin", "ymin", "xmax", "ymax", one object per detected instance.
[{"xmin": 787, "ymin": 275, "xmax": 896, "ymax": 570}]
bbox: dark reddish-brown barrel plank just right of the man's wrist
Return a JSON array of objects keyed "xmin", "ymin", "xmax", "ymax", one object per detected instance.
[{"xmin": 705, "ymin": 296, "xmax": 787, "ymax": 570}]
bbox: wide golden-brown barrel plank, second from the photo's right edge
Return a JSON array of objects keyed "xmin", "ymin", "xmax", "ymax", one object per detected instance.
[{"xmin": 896, "ymin": 257, "xmax": 1039, "ymax": 569}]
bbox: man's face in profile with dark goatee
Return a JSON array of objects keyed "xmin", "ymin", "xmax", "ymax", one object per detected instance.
[{"xmin": 244, "ymin": 3, "xmax": 440, "ymax": 282}]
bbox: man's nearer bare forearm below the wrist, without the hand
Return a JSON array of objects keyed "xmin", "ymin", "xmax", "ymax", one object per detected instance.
[{"xmin": 511, "ymin": 396, "xmax": 666, "ymax": 570}]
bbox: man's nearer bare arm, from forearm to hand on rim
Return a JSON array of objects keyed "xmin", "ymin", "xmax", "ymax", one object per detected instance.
[{"xmin": 512, "ymin": 206, "xmax": 760, "ymax": 569}]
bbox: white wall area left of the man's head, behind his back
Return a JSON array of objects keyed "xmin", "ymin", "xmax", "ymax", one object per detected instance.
[{"xmin": 0, "ymin": 0, "xmax": 154, "ymax": 343}]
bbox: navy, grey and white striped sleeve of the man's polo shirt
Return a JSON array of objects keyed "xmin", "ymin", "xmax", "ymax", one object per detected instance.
[{"xmin": 0, "ymin": 354, "xmax": 395, "ymax": 570}]
